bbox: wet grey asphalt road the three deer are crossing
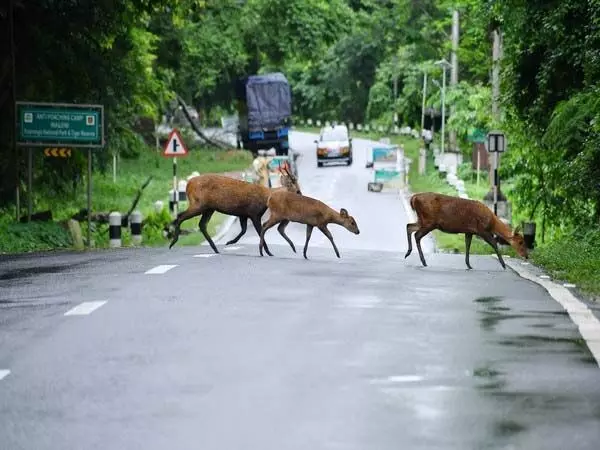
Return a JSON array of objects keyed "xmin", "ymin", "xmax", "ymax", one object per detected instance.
[{"xmin": 0, "ymin": 133, "xmax": 600, "ymax": 450}]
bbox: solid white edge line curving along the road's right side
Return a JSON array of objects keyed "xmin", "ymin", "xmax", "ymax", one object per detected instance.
[{"xmin": 508, "ymin": 261, "xmax": 600, "ymax": 366}]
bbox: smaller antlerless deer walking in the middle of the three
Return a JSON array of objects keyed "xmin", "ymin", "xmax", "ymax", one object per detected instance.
[{"xmin": 258, "ymin": 190, "xmax": 360, "ymax": 259}]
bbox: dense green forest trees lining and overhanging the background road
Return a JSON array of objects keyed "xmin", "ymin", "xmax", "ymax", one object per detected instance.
[{"xmin": 0, "ymin": 0, "xmax": 600, "ymax": 292}]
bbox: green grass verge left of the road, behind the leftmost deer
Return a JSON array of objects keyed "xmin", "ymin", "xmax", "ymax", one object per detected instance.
[{"xmin": 0, "ymin": 148, "xmax": 252, "ymax": 253}]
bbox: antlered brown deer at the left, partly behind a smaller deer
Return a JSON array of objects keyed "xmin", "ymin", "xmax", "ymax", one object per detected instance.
[{"xmin": 167, "ymin": 169, "xmax": 301, "ymax": 253}]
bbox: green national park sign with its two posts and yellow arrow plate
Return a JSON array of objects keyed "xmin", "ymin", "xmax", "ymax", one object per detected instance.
[{"xmin": 15, "ymin": 102, "xmax": 105, "ymax": 248}]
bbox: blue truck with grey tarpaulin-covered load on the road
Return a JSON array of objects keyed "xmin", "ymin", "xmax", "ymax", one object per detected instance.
[{"xmin": 236, "ymin": 72, "xmax": 292, "ymax": 156}]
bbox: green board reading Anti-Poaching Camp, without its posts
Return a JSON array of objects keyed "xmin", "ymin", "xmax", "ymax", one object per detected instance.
[{"xmin": 16, "ymin": 102, "xmax": 104, "ymax": 148}]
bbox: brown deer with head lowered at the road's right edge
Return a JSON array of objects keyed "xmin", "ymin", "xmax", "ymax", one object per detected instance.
[{"xmin": 404, "ymin": 192, "xmax": 529, "ymax": 270}]
